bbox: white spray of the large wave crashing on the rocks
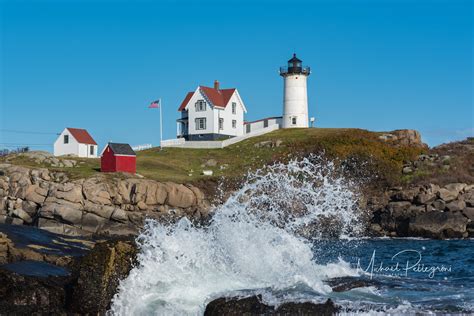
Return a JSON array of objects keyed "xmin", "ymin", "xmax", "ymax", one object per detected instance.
[{"xmin": 110, "ymin": 157, "xmax": 361, "ymax": 315}]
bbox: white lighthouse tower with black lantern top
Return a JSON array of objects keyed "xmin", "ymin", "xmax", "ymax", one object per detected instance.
[{"xmin": 280, "ymin": 54, "xmax": 311, "ymax": 128}]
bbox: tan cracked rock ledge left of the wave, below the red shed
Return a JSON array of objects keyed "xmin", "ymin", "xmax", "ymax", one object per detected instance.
[{"xmin": 0, "ymin": 164, "xmax": 209, "ymax": 236}]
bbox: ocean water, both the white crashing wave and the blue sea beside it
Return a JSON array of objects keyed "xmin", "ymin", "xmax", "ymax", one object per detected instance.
[{"xmin": 109, "ymin": 157, "xmax": 474, "ymax": 315}]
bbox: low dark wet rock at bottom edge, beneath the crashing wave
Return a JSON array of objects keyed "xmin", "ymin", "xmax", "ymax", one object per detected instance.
[{"xmin": 204, "ymin": 295, "xmax": 339, "ymax": 316}]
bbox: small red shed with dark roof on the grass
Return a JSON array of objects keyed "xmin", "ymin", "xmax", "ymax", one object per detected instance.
[{"xmin": 100, "ymin": 143, "xmax": 137, "ymax": 173}]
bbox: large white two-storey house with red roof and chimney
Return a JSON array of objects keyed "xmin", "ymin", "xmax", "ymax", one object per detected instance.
[{"xmin": 177, "ymin": 80, "xmax": 247, "ymax": 141}]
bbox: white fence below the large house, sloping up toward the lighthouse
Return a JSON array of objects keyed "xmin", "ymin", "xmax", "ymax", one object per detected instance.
[{"xmin": 161, "ymin": 124, "xmax": 280, "ymax": 149}]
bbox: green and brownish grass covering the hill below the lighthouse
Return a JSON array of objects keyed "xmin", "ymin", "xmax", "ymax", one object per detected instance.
[{"xmin": 1, "ymin": 128, "xmax": 422, "ymax": 188}]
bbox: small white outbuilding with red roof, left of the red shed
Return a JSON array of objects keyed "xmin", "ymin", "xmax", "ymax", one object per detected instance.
[{"xmin": 54, "ymin": 127, "xmax": 97, "ymax": 158}]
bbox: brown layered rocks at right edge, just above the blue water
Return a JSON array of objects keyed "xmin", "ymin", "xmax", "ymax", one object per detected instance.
[{"xmin": 369, "ymin": 183, "xmax": 474, "ymax": 238}]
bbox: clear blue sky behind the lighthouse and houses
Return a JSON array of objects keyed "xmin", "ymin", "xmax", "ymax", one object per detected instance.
[{"xmin": 0, "ymin": 0, "xmax": 474, "ymax": 150}]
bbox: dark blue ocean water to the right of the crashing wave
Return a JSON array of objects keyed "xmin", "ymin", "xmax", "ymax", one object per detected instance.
[{"xmin": 314, "ymin": 238, "xmax": 474, "ymax": 315}]
